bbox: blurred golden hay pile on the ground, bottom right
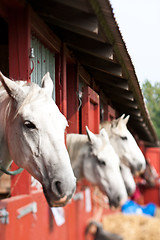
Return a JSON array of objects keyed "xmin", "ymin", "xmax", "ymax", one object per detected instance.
[{"xmin": 102, "ymin": 213, "xmax": 160, "ymax": 240}]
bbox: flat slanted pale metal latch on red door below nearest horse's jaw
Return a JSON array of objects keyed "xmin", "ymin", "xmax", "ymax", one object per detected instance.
[{"xmin": 17, "ymin": 202, "xmax": 37, "ymax": 219}]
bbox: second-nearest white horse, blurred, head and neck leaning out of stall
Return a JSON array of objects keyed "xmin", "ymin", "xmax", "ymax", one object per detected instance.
[{"xmin": 67, "ymin": 127, "xmax": 127, "ymax": 207}]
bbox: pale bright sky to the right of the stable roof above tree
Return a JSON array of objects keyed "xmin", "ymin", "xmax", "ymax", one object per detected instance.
[{"xmin": 110, "ymin": 0, "xmax": 160, "ymax": 86}]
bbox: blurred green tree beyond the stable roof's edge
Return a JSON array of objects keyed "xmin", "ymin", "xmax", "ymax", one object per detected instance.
[{"xmin": 142, "ymin": 80, "xmax": 160, "ymax": 139}]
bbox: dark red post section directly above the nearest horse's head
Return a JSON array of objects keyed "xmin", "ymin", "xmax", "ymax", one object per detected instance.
[{"xmin": 9, "ymin": 7, "xmax": 30, "ymax": 80}]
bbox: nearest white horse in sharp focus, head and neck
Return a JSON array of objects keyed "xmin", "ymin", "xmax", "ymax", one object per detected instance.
[{"xmin": 0, "ymin": 72, "xmax": 76, "ymax": 206}]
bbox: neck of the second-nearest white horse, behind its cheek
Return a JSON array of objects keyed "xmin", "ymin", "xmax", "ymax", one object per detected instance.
[{"xmin": 67, "ymin": 134, "xmax": 89, "ymax": 180}]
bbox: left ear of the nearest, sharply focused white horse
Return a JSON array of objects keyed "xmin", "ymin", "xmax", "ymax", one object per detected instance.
[{"xmin": 0, "ymin": 72, "xmax": 23, "ymax": 100}]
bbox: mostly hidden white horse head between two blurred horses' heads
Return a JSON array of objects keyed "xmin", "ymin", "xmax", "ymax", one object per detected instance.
[{"xmin": 120, "ymin": 163, "xmax": 136, "ymax": 196}]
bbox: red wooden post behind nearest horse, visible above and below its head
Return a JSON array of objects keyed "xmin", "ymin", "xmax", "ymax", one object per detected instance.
[{"xmin": 8, "ymin": 7, "xmax": 31, "ymax": 196}]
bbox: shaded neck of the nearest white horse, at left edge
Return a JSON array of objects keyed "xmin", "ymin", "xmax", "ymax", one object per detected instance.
[{"xmin": 0, "ymin": 90, "xmax": 11, "ymax": 172}]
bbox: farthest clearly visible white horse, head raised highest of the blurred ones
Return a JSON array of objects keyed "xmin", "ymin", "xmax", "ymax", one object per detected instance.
[{"xmin": 100, "ymin": 114, "xmax": 146, "ymax": 173}]
